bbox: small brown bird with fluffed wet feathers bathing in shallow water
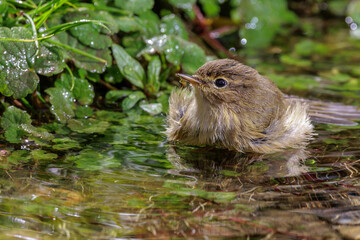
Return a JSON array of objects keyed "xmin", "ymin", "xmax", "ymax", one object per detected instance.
[{"xmin": 166, "ymin": 59, "xmax": 360, "ymax": 153}]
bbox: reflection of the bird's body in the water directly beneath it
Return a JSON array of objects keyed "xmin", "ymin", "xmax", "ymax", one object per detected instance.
[{"xmin": 167, "ymin": 143, "xmax": 308, "ymax": 178}]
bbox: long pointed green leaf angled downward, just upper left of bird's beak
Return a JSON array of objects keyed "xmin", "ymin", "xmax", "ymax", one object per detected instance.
[{"xmin": 112, "ymin": 44, "xmax": 145, "ymax": 88}]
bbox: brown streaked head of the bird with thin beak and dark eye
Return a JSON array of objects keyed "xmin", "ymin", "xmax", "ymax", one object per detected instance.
[{"xmin": 177, "ymin": 59, "xmax": 281, "ymax": 105}]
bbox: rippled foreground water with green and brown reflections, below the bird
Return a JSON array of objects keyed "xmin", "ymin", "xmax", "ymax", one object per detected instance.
[{"xmin": 0, "ymin": 118, "xmax": 360, "ymax": 239}]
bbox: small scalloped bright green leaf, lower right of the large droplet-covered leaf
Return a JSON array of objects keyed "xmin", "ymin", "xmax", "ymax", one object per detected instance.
[{"xmin": 55, "ymin": 73, "xmax": 95, "ymax": 105}]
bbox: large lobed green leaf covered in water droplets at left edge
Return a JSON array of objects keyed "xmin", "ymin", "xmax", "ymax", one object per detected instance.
[{"xmin": 0, "ymin": 27, "xmax": 65, "ymax": 98}]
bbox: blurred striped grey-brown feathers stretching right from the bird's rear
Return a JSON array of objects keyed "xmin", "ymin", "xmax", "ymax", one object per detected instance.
[{"xmin": 286, "ymin": 96, "xmax": 360, "ymax": 126}]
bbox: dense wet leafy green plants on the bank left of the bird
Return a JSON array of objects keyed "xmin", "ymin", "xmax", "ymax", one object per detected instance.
[{"xmin": 0, "ymin": 0, "xmax": 205, "ymax": 143}]
